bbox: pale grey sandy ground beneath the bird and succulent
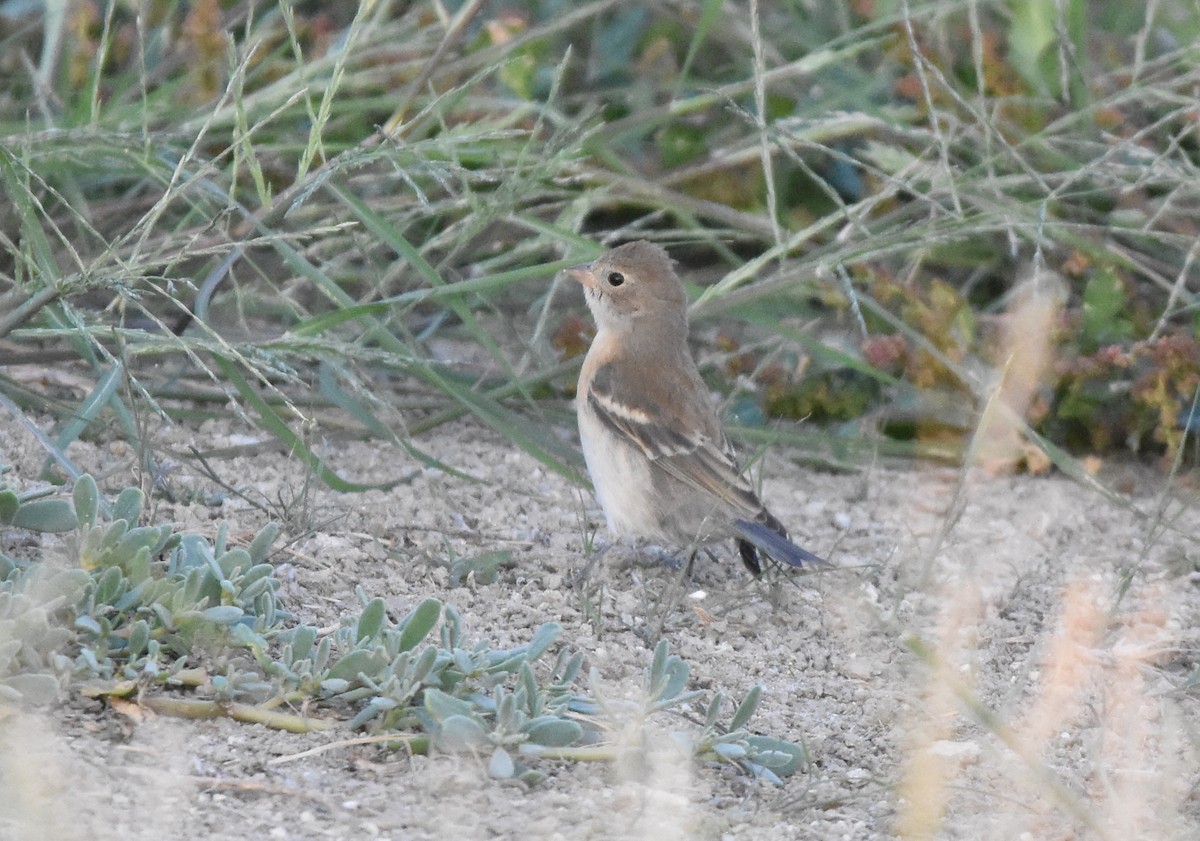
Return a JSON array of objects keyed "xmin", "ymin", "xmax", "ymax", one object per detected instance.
[{"xmin": 0, "ymin": 405, "xmax": 1200, "ymax": 841}]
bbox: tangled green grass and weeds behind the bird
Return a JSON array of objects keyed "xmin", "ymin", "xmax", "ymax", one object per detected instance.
[{"xmin": 0, "ymin": 0, "xmax": 1200, "ymax": 489}]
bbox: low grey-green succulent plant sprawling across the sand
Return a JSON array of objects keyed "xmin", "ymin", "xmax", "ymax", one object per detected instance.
[{"xmin": 0, "ymin": 467, "xmax": 806, "ymax": 783}]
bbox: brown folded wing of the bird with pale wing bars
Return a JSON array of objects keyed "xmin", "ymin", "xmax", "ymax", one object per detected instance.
[{"xmin": 587, "ymin": 368, "xmax": 762, "ymax": 517}]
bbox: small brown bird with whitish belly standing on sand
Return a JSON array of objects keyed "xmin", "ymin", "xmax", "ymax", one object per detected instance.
[{"xmin": 568, "ymin": 240, "xmax": 827, "ymax": 575}]
